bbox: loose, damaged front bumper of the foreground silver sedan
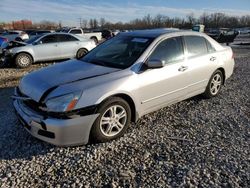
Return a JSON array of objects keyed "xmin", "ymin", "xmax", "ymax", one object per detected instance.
[{"xmin": 13, "ymin": 96, "xmax": 99, "ymax": 146}]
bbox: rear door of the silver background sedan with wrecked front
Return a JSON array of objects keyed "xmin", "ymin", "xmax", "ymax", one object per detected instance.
[{"xmin": 58, "ymin": 34, "xmax": 80, "ymax": 58}]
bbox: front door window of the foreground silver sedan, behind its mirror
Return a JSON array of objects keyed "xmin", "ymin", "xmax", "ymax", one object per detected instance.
[{"xmin": 150, "ymin": 37, "xmax": 184, "ymax": 63}]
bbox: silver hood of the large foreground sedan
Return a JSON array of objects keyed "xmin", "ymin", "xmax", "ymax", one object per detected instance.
[{"xmin": 19, "ymin": 60, "xmax": 120, "ymax": 102}]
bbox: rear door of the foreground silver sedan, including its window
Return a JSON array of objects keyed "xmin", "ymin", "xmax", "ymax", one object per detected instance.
[{"xmin": 184, "ymin": 36, "xmax": 218, "ymax": 97}]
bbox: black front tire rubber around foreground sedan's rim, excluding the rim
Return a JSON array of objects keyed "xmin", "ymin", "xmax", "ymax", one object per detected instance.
[{"xmin": 90, "ymin": 97, "xmax": 131, "ymax": 143}]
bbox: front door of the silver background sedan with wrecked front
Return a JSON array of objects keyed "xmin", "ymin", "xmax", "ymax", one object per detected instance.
[{"xmin": 33, "ymin": 34, "xmax": 60, "ymax": 61}]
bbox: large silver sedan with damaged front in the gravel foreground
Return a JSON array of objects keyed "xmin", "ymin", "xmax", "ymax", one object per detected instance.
[{"xmin": 13, "ymin": 30, "xmax": 234, "ymax": 145}]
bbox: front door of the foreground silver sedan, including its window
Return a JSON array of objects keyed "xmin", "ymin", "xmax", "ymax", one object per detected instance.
[{"xmin": 138, "ymin": 37, "xmax": 188, "ymax": 114}]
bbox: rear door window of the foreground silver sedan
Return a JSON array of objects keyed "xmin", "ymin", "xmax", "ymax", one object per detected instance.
[{"xmin": 184, "ymin": 36, "xmax": 208, "ymax": 57}]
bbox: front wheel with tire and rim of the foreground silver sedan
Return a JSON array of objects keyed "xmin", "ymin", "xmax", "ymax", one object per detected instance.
[{"xmin": 90, "ymin": 97, "xmax": 131, "ymax": 143}]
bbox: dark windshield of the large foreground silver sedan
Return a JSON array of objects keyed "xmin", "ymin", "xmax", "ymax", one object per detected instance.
[{"xmin": 81, "ymin": 36, "xmax": 153, "ymax": 69}]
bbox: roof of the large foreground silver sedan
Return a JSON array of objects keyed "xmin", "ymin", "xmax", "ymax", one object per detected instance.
[{"xmin": 120, "ymin": 28, "xmax": 183, "ymax": 38}]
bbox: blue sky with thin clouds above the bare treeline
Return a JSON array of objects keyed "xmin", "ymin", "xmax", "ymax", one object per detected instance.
[{"xmin": 0, "ymin": 0, "xmax": 250, "ymax": 26}]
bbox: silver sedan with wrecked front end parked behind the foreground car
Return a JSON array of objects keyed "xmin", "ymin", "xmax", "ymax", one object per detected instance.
[{"xmin": 5, "ymin": 33, "xmax": 96, "ymax": 68}]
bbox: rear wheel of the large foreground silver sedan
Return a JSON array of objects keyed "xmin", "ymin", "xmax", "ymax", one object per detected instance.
[{"xmin": 203, "ymin": 70, "xmax": 223, "ymax": 98}]
